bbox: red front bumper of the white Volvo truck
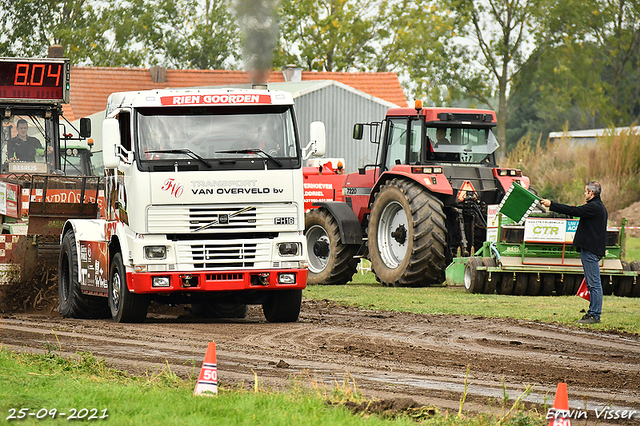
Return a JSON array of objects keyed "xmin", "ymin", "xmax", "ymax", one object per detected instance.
[{"xmin": 127, "ymin": 269, "xmax": 307, "ymax": 293}]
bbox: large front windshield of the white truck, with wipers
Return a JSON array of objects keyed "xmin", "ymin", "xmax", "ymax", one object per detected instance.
[{"xmin": 136, "ymin": 106, "xmax": 299, "ymax": 170}]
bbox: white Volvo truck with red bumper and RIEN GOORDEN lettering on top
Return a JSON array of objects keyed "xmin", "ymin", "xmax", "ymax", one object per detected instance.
[{"xmin": 59, "ymin": 89, "xmax": 325, "ymax": 322}]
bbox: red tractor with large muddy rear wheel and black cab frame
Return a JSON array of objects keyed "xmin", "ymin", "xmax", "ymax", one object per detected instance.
[{"xmin": 304, "ymin": 101, "xmax": 529, "ymax": 287}]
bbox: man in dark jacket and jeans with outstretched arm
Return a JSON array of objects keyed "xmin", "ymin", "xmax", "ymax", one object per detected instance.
[{"xmin": 540, "ymin": 181, "xmax": 608, "ymax": 324}]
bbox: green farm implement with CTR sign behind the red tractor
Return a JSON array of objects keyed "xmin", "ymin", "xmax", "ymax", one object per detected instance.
[{"xmin": 447, "ymin": 184, "xmax": 640, "ymax": 297}]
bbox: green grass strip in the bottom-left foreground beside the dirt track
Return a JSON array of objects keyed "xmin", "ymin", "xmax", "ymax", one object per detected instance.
[{"xmin": 0, "ymin": 348, "xmax": 544, "ymax": 426}]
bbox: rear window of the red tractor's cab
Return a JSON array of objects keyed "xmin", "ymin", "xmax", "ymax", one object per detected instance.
[{"xmin": 427, "ymin": 127, "xmax": 500, "ymax": 163}]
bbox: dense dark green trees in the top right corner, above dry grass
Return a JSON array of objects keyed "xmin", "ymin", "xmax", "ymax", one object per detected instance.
[{"xmin": 512, "ymin": 0, "xmax": 640, "ymax": 143}]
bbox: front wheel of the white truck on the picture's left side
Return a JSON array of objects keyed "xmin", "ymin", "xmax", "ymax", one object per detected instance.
[{"xmin": 109, "ymin": 253, "xmax": 150, "ymax": 322}]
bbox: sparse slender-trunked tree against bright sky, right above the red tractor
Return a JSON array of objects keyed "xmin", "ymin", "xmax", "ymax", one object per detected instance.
[{"xmin": 433, "ymin": 0, "xmax": 545, "ymax": 154}]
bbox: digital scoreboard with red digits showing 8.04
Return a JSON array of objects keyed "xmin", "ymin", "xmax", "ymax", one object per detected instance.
[{"xmin": 0, "ymin": 58, "xmax": 71, "ymax": 103}]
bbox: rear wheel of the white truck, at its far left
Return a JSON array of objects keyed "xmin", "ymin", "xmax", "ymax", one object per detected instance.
[{"xmin": 58, "ymin": 231, "xmax": 109, "ymax": 319}]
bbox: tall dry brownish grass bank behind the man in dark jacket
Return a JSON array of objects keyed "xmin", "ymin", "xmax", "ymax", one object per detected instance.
[{"xmin": 504, "ymin": 129, "xmax": 640, "ymax": 213}]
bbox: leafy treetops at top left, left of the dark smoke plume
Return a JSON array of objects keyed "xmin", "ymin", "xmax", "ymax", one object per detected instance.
[{"xmin": 0, "ymin": 0, "xmax": 239, "ymax": 69}]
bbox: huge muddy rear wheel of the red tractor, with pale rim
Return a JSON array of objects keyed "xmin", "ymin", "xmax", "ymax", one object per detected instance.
[{"xmin": 368, "ymin": 178, "xmax": 447, "ymax": 287}]
